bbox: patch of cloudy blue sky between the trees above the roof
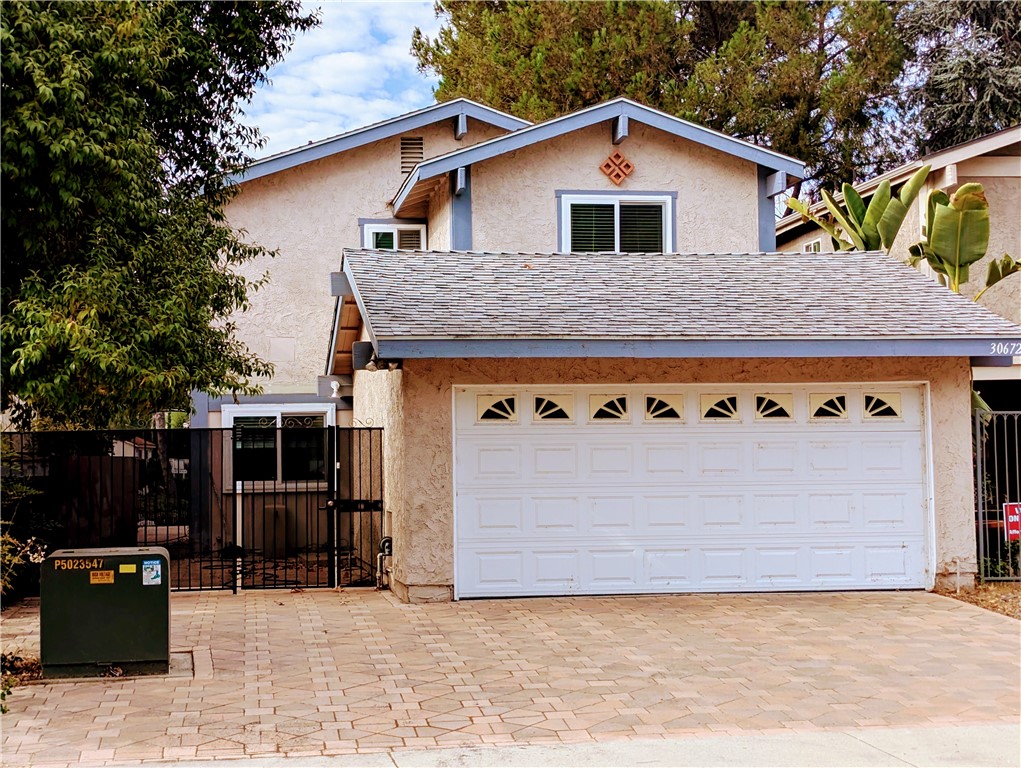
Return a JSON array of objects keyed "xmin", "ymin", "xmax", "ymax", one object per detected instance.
[{"xmin": 246, "ymin": 0, "xmax": 440, "ymax": 157}]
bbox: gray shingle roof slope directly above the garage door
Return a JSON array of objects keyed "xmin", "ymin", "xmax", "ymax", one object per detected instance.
[{"xmin": 344, "ymin": 250, "xmax": 1021, "ymax": 340}]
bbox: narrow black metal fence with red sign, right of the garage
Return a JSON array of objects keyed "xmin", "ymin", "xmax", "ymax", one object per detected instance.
[{"xmin": 975, "ymin": 411, "xmax": 1021, "ymax": 581}]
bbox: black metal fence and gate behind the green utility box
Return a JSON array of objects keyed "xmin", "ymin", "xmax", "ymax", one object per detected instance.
[{"xmin": 2, "ymin": 422, "xmax": 384, "ymax": 591}]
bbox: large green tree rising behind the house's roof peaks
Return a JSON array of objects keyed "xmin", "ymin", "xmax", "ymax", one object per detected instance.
[{"xmin": 412, "ymin": 0, "xmax": 910, "ymax": 192}]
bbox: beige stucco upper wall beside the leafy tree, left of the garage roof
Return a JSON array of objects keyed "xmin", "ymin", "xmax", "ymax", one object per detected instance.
[{"xmin": 227, "ymin": 121, "xmax": 503, "ymax": 393}]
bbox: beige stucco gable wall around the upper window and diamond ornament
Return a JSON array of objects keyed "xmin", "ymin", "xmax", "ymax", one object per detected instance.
[{"xmin": 472, "ymin": 122, "xmax": 759, "ymax": 252}]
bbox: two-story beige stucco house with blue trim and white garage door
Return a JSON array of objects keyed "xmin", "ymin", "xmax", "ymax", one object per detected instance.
[{"xmin": 215, "ymin": 99, "xmax": 1021, "ymax": 602}]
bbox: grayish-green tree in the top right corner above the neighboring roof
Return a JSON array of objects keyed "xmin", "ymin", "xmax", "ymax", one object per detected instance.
[{"xmin": 900, "ymin": 0, "xmax": 1021, "ymax": 152}]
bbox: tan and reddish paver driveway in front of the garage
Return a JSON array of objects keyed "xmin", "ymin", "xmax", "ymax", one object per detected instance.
[{"xmin": 2, "ymin": 590, "xmax": 1021, "ymax": 767}]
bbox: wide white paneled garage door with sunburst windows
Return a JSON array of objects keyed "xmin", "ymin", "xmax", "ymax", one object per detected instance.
[{"xmin": 454, "ymin": 384, "xmax": 928, "ymax": 597}]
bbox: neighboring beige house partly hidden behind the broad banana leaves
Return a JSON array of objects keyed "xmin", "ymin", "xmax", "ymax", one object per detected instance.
[{"xmin": 777, "ymin": 126, "xmax": 1021, "ymax": 410}]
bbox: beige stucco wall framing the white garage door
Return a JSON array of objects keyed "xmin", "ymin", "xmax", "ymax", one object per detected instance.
[{"xmin": 381, "ymin": 357, "xmax": 976, "ymax": 601}]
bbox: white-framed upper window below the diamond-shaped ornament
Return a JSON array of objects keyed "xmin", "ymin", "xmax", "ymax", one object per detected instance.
[{"xmin": 560, "ymin": 195, "xmax": 674, "ymax": 253}]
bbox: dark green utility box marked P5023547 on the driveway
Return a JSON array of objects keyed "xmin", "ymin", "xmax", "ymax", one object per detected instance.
[{"xmin": 39, "ymin": 546, "xmax": 171, "ymax": 677}]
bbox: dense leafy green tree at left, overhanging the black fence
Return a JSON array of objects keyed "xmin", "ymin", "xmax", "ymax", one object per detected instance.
[{"xmin": 0, "ymin": 0, "xmax": 317, "ymax": 426}]
